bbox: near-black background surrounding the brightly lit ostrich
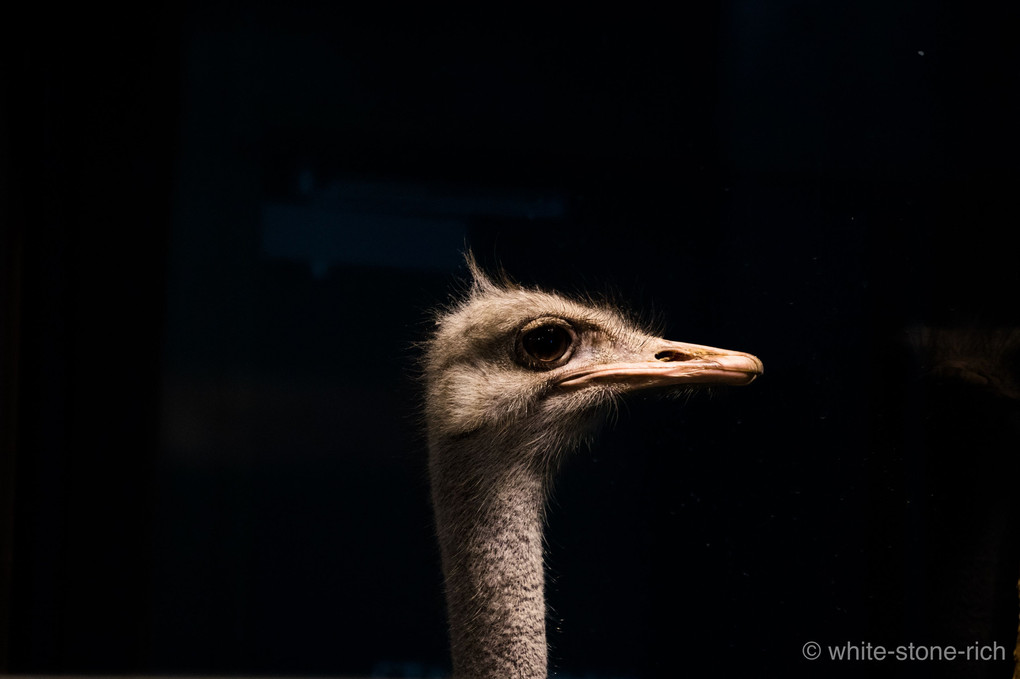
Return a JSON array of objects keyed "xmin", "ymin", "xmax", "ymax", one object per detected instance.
[{"xmin": 0, "ymin": 0, "xmax": 1020, "ymax": 679}]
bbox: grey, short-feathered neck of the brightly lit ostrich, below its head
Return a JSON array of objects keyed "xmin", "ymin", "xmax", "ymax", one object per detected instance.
[{"xmin": 430, "ymin": 438, "xmax": 548, "ymax": 679}]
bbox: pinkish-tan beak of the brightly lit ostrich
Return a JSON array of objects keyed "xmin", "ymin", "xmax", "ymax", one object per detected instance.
[{"xmin": 558, "ymin": 340, "xmax": 764, "ymax": 389}]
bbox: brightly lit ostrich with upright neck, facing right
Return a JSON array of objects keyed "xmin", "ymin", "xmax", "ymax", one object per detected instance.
[{"xmin": 423, "ymin": 253, "xmax": 762, "ymax": 679}]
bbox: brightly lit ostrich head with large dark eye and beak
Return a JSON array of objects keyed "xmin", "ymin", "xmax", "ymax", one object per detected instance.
[{"xmin": 424, "ymin": 254, "xmax": 762, "ymax": 464}]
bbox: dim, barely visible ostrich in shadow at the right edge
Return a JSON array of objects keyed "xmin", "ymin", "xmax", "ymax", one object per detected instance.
[{"xmin": 900, "ymin": 323, "xmax": 1020, "ymax": 668}]
